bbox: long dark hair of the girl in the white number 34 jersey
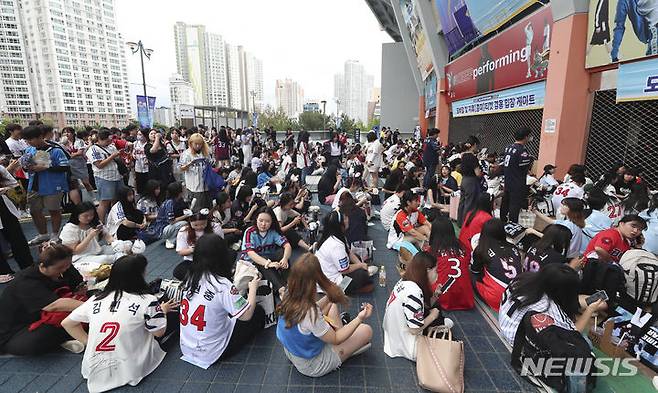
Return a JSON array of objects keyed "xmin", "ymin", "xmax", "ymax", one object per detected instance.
[{"xmin": 184, "ymin": 233, "xmax": 233, "ymax": 299}]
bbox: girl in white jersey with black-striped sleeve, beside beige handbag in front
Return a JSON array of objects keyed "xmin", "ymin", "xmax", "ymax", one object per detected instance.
[{"xmin": 383, "ymin": 251, "xmax": 452, "ymax": 361}]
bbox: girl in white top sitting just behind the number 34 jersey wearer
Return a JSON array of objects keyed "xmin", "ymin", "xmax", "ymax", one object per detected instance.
[{"xmin": 173, "ymin": 209, "xmax": 224, "ymax": 280}]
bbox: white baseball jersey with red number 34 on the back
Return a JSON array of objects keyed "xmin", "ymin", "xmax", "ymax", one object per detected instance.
[{"xmin": 180, "ymin": 274, "xmax": 249, "ymax": 369}]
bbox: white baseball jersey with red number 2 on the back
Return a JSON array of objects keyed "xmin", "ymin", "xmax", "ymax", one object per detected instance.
[{"xmin": 69, "ymin": 292, "xmax": 167, "ymax": 392}]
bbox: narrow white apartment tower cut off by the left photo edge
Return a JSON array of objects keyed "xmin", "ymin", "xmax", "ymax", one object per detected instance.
[{"xmin": 0, "ymin": 0, "xmax": 35, "ymax": 122}]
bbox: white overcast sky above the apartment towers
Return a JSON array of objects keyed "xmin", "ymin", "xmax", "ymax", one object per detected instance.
[{"xmin": 116, "ymin": 0, "xmax": 392, "ymax": 112}]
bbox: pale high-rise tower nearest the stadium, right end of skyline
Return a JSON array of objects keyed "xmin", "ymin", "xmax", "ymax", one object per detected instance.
[{"xmin": 334, "ymin": 60, "xmax": 374, "ymax": 122}]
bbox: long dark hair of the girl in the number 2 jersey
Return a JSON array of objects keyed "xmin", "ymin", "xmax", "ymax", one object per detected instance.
[{"xmin": 95, "ymin": 254, "xmax": 150, "ymax": 309}]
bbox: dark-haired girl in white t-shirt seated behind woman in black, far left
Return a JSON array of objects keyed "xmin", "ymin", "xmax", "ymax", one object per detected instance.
[{"xmin": 59, "ymin": 202, "xmax": 115, "ymax": 273}]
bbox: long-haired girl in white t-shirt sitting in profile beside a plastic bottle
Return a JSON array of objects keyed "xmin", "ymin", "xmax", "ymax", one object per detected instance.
[{"xmin": 315, "ymin": 210, "xmax": 377, "ymax": 294}]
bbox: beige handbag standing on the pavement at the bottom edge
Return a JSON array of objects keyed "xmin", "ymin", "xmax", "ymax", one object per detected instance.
[{"xmin": 416, "ymin": 326, "xmax": 464, "ymax": 393}]
